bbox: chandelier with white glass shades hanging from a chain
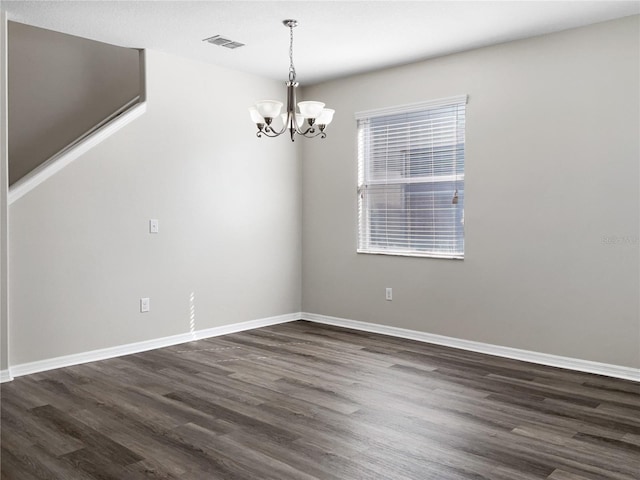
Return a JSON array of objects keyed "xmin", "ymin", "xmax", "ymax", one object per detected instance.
[{"xmin": 249, "ymin": 20, "xmax": 335, "ymax": 142}]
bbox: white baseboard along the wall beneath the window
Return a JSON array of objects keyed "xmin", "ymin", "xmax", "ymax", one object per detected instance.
[{"xmin": 302, "ymin": 312, "xmax": 640, "ymax": 382}]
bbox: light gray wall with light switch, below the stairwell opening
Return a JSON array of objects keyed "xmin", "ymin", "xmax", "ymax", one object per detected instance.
[{"xmin": 9, "ymin": 51, "xmax": 301, "ymax": 365}]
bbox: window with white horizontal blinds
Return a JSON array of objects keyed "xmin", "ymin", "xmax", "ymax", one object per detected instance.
[{"xmin": 356, "ymin": 95, "xmax": 467, "ymax": 258}]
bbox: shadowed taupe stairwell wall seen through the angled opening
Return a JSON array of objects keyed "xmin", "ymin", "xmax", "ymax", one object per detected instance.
[{"xmin": 8, "ymin": 22, "xmax": 141, "ymax": 184}]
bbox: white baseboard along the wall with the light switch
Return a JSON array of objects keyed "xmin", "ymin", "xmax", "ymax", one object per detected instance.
[{"xmin": 9, "ymin": 312, "xmax": 302, "ymax": 379}]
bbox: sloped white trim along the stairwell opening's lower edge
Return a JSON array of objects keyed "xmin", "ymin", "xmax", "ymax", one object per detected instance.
[{"xmin": 8, "ymin": 102, "xmax": 147, "ymax": 205}]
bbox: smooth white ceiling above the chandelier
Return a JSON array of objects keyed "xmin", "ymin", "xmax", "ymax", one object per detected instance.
[{"xmin": 2, "ymin": 0, "xmax": 640, "ymax": 85}]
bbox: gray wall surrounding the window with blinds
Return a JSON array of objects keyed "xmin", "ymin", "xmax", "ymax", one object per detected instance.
[{"xmin": 302, "ymin": 16, "xmax": 640, "ymax": 367}]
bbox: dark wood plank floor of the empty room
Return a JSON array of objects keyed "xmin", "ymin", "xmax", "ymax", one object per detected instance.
[{"xmin": 1, "ymin": 321, "xmax": 640, "ymax": 480}]
